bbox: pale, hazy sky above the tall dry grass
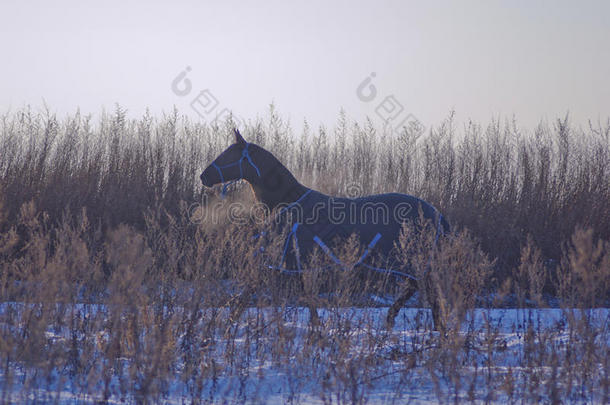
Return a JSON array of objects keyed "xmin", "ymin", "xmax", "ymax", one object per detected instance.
[{"xmin": 0, "ymin": 0, "xmax": 610, "ymax": 129}]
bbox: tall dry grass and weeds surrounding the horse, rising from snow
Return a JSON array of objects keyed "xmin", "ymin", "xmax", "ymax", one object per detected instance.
[{"xmin": 0, "ymin": 108, "xmax": 610, "ymax": 403}]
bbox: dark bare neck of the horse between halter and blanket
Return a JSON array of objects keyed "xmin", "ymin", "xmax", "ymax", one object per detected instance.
[{"xmin": 250, "ymin": 162, "xmax": 309, "ymax": 211}]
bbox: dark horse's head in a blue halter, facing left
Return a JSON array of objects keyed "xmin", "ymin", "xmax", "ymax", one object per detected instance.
[{"xmin": 199, "ymin": 129, "xmax": 261, "ymax": 187}]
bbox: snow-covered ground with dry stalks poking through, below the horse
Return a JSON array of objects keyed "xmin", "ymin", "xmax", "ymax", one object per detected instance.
[{"xmin": 0, "ymin": 303, "xmax": 610, "ymax": 404}]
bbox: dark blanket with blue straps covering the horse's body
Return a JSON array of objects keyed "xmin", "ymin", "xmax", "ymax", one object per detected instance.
[{"xmin": 256, "ymin": 189, "xmax": 449, "ymax": 278}]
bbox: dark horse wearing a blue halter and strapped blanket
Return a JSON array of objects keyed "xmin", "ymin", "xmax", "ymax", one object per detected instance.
[{"xmin": 201, "ymin": 130, "xmax": 449, "ymax": 328}]
